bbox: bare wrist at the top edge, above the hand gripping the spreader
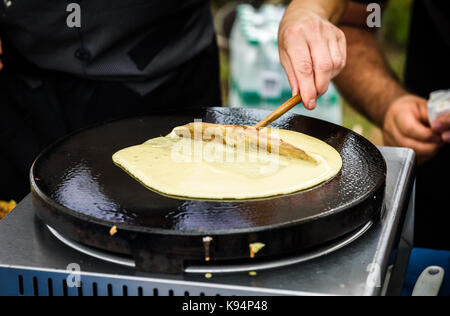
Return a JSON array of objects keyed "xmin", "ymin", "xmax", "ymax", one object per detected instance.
[{"xmin": 289, "ymin": 0, "xmax": 348, "ymax": 24}]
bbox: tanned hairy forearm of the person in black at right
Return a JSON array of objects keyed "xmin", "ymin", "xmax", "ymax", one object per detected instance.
[{"xmin": 335, "ymin": 26, "xmax": 407, "ymax": 126}]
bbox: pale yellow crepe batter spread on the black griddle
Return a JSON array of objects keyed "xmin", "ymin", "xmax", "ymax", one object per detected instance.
[{"xmin": 113, "ymin": 129, "xmax": 342, "ymax": 200}]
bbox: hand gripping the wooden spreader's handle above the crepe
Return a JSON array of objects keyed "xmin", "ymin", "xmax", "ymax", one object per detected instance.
[{"xmin": 279, "ymin": 2, "xmax": 347, "ymax": 110}]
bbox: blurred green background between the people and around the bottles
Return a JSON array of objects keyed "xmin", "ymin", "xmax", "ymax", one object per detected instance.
[{"xmin": 212, "ymin": 0, "xmax": 413, "ymax": 145}]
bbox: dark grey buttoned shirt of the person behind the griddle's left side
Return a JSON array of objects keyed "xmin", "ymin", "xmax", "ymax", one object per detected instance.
[{"xmin": 0, "ymin": 0, "xmax": 214, "ymax": 93}]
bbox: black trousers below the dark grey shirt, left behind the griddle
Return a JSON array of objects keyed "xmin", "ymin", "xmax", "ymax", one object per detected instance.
[{"xmin": 0, "ymin": 43, "xmax": 221, "ymax": 201}]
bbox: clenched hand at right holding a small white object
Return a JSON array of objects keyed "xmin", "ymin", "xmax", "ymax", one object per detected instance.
[{"xmin": 383, "ymin": 95, "xmax": 442, "ymax": 164}]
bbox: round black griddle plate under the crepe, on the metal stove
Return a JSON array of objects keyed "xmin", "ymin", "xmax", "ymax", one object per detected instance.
[{"xmin": 31, "ymin": 108, "xmax": 386, "ymax": 273}]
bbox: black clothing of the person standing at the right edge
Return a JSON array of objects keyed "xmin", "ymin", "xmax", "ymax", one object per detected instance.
[{"xmin": 354, "ymin": 0, "xmax": 450, "ymax": 249}]
